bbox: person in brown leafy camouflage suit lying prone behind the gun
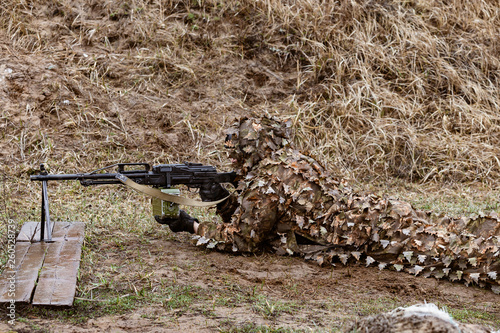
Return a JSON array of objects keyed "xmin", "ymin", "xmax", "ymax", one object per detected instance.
[{"xmin": 157, "ymin": 118, "xmax": 500, "ymax": 293}]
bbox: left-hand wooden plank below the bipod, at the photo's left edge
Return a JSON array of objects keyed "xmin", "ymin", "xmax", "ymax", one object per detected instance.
[{"xmin": 0, "ymin": 242, "xmax": 48, "ymax": 303}]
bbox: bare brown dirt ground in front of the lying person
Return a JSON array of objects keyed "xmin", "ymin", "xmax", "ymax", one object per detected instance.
[{"xmin": 0, "ymin": 231, "xmax": 500, "ymax": 332}]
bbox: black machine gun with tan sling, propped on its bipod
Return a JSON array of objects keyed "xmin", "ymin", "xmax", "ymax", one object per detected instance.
[{"xmin": 30, "ymin": 162, "xmax": 237, "ymax": 241}]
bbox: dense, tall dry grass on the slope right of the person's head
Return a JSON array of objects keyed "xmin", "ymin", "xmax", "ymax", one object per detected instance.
[{"xmin": 252, "ymin": 1, "xmax": 500, "ymax": 181}]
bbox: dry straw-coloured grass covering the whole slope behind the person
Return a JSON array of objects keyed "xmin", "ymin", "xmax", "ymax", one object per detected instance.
[{"xmin": 0, "ymin": 0, "xmax": 500, "ymax": 183}]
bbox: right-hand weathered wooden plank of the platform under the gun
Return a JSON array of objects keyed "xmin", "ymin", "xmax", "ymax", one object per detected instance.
[{"xmin": 32, "ymin": 222, "xmax": 85, "ymax": 306}]
